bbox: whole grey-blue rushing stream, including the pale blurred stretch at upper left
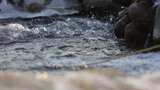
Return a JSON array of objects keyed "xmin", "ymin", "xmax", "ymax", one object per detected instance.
[{"xmin": 0, "ymin": 0, "xmax": 160, "ymax": 75}]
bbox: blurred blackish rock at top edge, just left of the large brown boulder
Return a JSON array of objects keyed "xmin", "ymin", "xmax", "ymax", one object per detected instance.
[{"xmin": 79, "ymin": 0, "xmax": 121, "ymax": 16}]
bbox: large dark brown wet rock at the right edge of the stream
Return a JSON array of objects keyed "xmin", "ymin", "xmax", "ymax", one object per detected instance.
[{"xmin": 115, "ymin": 0, "xmax": 154, "ymax": 48}]
